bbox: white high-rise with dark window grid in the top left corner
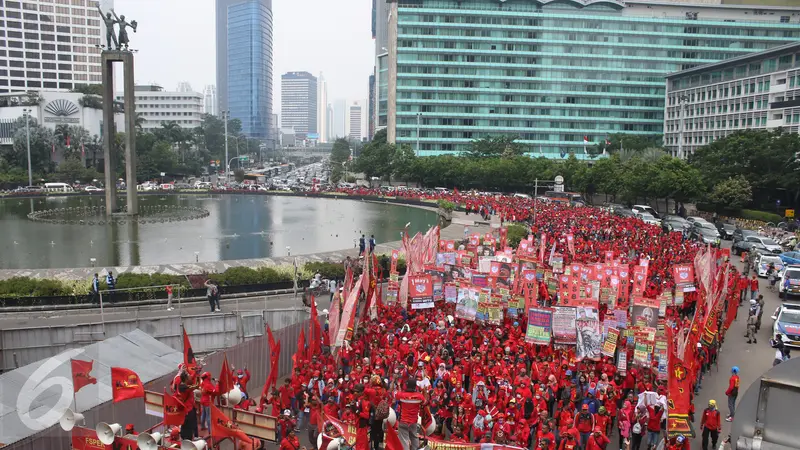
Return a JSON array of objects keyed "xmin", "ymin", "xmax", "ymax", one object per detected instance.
[{"xmin": 0, "ymin": 0, "xmax": 114, "ymax": 93}]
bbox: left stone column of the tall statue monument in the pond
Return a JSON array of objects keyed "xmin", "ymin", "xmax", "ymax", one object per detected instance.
[{"xmin": 101, "ymin": 52, "xmax": 117, "ymax": 217}]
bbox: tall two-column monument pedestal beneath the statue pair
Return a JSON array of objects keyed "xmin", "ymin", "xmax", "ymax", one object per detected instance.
[{"xmin": 101, "ymin": 50, "xmax": 139, "ymax": 216}]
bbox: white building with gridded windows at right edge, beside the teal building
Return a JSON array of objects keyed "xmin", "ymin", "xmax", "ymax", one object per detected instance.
[{"xmin": 664, "ymin": 42, "xmax": 800, "ymax": 158}]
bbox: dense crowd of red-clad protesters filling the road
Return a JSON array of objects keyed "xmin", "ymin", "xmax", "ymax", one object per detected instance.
[{"xmin": 172, "ymin": 189, "xmax": 738, "ymax": 450}]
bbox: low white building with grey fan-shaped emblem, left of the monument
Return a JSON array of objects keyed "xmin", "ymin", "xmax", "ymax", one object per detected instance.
[{"xmin": 0, "ymin": 90, "xmax": 125, "ymax": 163}]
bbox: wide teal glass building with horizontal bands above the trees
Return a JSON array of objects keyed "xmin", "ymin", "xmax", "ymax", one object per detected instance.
[{"xmin": 386, "ymin": 0, "xmax": 800, "ymax": 158}]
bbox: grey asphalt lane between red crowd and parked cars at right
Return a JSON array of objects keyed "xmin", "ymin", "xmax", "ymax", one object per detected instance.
[{"xmin": 692, "ymin": 248, "xmax": 781, "ymax": 448}]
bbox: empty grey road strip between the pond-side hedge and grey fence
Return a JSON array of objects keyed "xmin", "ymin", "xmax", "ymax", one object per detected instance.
[{"xmin": 0, "ymin": 293, "xmax": 312, "ymax": 330}]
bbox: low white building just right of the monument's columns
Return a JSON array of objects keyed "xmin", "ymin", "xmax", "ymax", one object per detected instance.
[{"xmin": 116, "ymin": 85, "xmax": 204, "ymax": 130}]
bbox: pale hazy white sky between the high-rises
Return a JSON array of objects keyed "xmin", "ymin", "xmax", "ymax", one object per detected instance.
[{"xmin": 114, "ymin": 0, "xmax": 375, "ymax": 113}]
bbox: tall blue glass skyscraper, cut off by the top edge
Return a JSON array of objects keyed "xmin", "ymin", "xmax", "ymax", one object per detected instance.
[{"xmin": 217, "ymin": 0, "xmax": 273, "ymax": 142}]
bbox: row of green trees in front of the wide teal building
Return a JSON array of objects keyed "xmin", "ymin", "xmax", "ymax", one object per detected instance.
[{"xmin": 354, "ymin": 130, "xmax": 800, "ymax": 209}]
